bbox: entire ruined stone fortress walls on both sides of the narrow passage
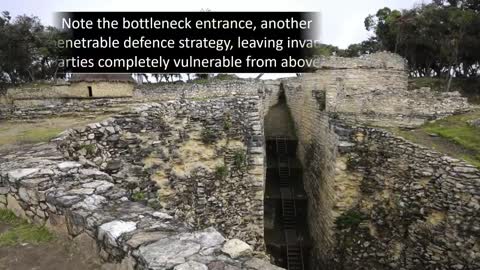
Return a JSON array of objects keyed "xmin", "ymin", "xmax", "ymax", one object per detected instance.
[{"xmin": 0, "ymin": 53, "xmax": 480, "ymax": 269}]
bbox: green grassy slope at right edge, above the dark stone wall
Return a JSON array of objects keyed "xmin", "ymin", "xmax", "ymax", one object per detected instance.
[{"xmin": 393, "ymin": 110, "xmax": 480, "ymax": 167}]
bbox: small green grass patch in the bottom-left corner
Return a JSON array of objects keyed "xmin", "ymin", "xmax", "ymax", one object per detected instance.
[{"xmin": 0, "ymin": 209, "xmax": 55, "ymax": 247}]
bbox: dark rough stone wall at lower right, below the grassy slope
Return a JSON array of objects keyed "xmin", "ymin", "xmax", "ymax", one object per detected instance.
[{"xmin": 330, "ymin": 125, "xmax": 480, "ymax": 269}]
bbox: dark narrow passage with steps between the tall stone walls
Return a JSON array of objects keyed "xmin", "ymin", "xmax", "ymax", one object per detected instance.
[{"xmin": 265, "ymin": 97, "xmax": 310, "ymax": 270}]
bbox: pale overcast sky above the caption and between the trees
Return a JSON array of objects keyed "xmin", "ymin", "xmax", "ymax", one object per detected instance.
[{"xmin": 0, "ymin": 0, "xmax": 430, "ymax": 79}]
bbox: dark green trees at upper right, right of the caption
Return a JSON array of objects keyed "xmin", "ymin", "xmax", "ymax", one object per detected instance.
[{"xmin": 317, "ymin": 0, "xmax": 480, "ymax": 82}]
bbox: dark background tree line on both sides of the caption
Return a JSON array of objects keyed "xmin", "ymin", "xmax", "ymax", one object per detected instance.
[{"xmin": 0, "ymin": 0, "xmax": 480, "ymax": 87}]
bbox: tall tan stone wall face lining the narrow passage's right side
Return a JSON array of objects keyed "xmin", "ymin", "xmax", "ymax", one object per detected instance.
[{"xmin": 283, "ymin": 79, "xmax": 337, "ymax": 267}]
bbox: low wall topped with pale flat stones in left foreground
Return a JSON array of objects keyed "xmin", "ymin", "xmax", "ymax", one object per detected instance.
[{"xmin": 0, "ymin": 143, "xmax": 281, "ymax": 270}]
